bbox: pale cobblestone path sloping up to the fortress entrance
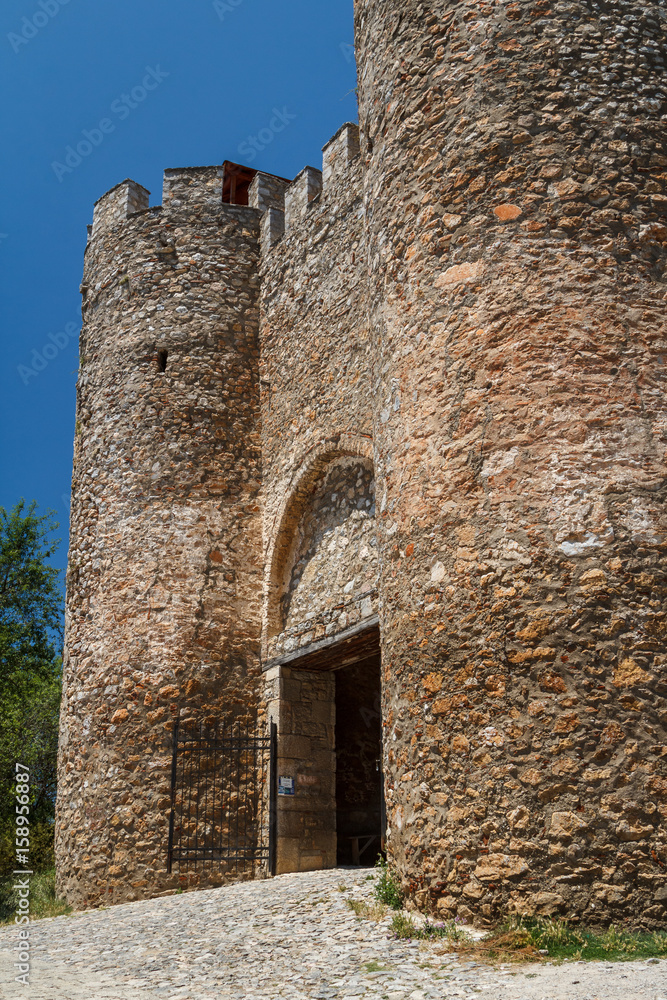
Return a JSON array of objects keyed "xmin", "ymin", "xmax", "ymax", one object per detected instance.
[{"xmin": 0, "ymin": 869, "xmax": 667, "ymax": 1000}]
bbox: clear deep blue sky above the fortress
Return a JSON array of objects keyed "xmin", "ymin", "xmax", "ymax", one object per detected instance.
[{"xmin": 0, "ymin": 0, "xmax": 357, "ymax": 580}]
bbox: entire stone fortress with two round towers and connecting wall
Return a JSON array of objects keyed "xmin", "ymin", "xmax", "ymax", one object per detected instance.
[{"xmin": 56, "ymin": 0, "xmax": 667, "ymax": 927}]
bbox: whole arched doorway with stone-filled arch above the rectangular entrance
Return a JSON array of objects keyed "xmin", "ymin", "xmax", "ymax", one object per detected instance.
[{"xmin": 264, "ymin": 453, "xmax": 383, "ymax": 873}]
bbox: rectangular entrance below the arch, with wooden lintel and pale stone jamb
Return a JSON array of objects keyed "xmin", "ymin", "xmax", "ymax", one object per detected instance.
[{"xmin": 264, "ymin": 617, "xmax": 384, "ymax": 875}]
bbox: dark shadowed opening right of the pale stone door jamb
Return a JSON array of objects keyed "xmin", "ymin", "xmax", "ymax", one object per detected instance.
[{"xmin": 335, "ymin": 652, "xmax": 383, "ymax": 865}]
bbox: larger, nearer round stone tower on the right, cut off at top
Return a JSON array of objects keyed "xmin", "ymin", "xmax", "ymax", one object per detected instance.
[{"xmin": 355, "ymin": 0, "xmax": 667, "ymax": 926}]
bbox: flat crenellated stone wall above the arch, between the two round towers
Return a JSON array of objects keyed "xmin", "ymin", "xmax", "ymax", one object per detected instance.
[{"xmin": 260, "ymin": 125, "xmax": 372, "ymax": 658}]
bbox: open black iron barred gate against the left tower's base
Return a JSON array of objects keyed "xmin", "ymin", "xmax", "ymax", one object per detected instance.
[{"xmin": 168, "ymin": 720, "xmax": 277, "ymax": 875}]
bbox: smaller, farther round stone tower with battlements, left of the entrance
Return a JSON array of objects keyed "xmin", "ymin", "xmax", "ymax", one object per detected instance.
[{"xmin": 56, "ymin": 168, "xmax": 261, "ymax": 906}]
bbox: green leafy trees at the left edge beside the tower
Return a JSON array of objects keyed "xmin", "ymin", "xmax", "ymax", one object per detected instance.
[{"xmin": 0, "ymin": 501, "xmax": 62, "ymax": 873}]
